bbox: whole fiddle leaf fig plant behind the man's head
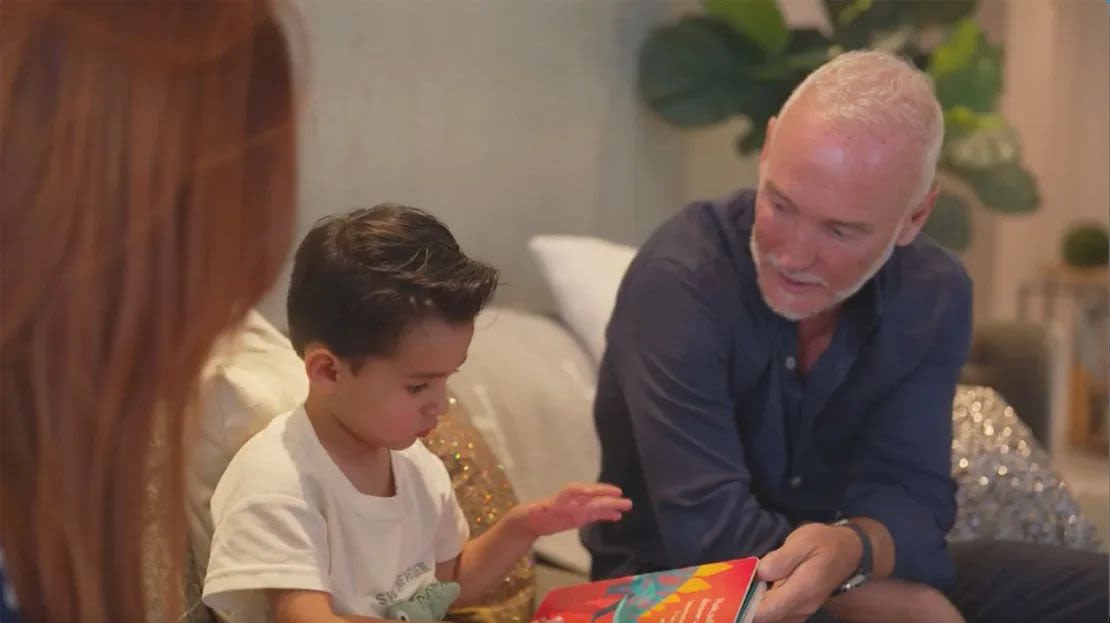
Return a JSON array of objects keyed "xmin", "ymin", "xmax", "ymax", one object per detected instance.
[{"xmin": 638, "ymin": 0, "xmax": 1040, "ymax": 251}]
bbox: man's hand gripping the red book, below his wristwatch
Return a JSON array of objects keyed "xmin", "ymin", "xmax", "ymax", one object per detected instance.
[{"xmin": 755, "ymin": 523, "xmax": 862, "ymax": 623}]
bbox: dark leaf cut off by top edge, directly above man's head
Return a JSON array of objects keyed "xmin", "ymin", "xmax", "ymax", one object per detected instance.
[{"xmin": 825, "ymin": 0, "xmax": 976, "ymax": 50}]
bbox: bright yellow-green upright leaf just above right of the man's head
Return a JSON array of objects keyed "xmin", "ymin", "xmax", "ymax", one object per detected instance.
[{"xmin": 929, "ymin": 19, "xmax": 1002, "ymax": 112}]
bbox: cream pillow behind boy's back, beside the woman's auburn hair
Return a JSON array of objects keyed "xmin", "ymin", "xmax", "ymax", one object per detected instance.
[{"xmin": 185, "ymin": 311, "xmax": 309, "ymax": 577}]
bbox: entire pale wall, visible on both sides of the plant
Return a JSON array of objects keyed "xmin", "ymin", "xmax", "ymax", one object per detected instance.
[{"xmin": 262, "ymin": 0, "xmax": 1110, "ymax": 324}]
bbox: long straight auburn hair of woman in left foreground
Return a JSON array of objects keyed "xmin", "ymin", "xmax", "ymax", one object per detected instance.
[{"xmin": 0, "ymin": 0, "xmax": 295, "ymax": 623}]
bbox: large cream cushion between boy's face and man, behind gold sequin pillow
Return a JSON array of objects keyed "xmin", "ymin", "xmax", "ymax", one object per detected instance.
[{"xmin": 450, "ymin": 308, "xmax": 601, "ymax": 573}]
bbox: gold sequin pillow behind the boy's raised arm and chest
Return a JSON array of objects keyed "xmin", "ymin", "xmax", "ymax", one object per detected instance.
[{"xmin": 424, "ymin": 399, "xmax": 536, "ymax": 623}]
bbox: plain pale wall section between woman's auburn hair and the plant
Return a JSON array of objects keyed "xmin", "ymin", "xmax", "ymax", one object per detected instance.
[{"xmin": 261, "ymin": 0, "xmax": 682, "ymax": 325}]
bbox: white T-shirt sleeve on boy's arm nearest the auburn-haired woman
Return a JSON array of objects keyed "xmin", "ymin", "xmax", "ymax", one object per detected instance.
[{"xmin": 204, "ymin": 494, "xmax": 330, "ymax": 612}]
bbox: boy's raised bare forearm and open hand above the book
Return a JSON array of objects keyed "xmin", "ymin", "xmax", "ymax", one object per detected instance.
[{"xmin": 435, "ymin": 484, "xmax": 632, "ymax": 605}]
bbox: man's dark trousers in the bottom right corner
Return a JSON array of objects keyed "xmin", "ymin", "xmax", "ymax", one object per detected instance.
[{"xmin": 807, "ymin": 541, "xmax": 1110, "ymax": 623}]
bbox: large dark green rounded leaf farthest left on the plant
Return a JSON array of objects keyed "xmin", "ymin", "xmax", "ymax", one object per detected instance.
[{"xmin": 639, "ymin": 17, "xmax": 774, "ymax": 125}]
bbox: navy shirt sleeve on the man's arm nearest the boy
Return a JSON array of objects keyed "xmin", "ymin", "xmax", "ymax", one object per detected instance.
[{"xmin": 606, "ymin": 260, "xmax": 790, "ymax": 566}]
